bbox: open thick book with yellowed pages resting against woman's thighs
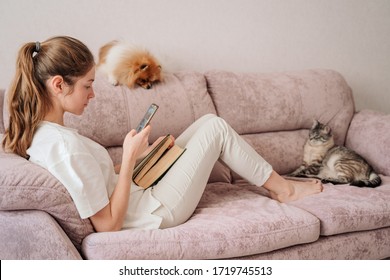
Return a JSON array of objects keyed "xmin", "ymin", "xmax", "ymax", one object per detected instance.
[{"xmin": 133, "ymin": 134, "xmax": 185, "ymax": 189}]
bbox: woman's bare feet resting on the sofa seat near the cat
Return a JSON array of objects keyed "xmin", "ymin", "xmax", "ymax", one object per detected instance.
[{"xmin": 270, "ymin": 180, "xmax": 323, "ymax": 202}]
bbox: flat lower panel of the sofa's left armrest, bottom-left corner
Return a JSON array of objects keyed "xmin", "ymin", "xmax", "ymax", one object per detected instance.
[{"xmin": 0, "ymin": 210, "xmax": 82, "ymax": 260}]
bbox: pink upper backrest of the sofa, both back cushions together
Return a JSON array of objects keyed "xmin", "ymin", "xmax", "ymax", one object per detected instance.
[{"xmin": 0, "ymin": 69, "xmax": 354, "ymax": 151}]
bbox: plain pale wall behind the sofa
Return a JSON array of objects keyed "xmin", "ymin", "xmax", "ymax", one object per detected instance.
[{"xmin": 0, "ymin": 0, "xmax": 390, "ymax": 113}]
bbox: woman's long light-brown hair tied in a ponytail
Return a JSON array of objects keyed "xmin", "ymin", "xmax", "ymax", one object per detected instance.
[{"xmin": 3, "ymin": 36, "xmax": 95, "ymax": 158}]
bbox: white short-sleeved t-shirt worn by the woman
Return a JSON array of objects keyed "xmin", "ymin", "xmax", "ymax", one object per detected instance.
[{"xmin": 27, "ymin": 121, "xmax": 161, "ymax": 228}]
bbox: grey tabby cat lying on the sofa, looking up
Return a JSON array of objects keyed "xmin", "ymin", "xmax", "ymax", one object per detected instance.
[{"xmin": 289, "ymin": 121, "xmax": 382, "ymax": 188}]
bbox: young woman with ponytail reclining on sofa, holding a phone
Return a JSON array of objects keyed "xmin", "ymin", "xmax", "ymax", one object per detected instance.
[{"xmin": 3, "ymin": 37, "xmax": 322, "ymax": 231}]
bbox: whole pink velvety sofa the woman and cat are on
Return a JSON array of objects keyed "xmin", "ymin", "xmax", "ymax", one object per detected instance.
[{"xmin": 0, "ymin": 69, "xmax": 390, "ymax": 259}]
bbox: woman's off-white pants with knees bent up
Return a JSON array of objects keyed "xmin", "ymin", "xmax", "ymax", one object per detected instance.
[{"xmin": 152, "ymin": 114, "xmax": 272, "ymax": 228}]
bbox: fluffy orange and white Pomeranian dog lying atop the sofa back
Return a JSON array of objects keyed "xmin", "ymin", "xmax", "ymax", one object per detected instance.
[{"xmin": 98, "ymin": 41, "xmax": 162, "ymax": 89}]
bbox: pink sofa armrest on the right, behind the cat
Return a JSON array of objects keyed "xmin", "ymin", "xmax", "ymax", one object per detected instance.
[{"xmin": 345, "ymin": 110, "xmax": 390, "ymax": 176}]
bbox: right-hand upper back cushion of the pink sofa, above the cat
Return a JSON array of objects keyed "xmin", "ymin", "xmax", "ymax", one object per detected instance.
[{"xmin": 205, "ymin": 70, "xmax": 354, "ymax": 144}]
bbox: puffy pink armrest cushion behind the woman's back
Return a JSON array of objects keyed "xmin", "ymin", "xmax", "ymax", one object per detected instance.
[{"xmin": 0, "ymin": 145, "xmax": 93, "ymax": 248}]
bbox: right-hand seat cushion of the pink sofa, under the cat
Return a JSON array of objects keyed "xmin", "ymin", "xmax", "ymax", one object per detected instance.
[{"xmin": 289, "ymin": 176, "xmax": 390, "ymax": 235}]
